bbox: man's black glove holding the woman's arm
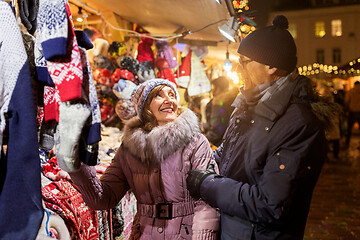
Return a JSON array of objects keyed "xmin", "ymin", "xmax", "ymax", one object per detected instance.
[{"xmin": 186, "ymin": 164, "xmax": 217, "ymax": 199}]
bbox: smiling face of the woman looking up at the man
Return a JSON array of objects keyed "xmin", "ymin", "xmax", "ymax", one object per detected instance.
[{"xmin": 150, "ymin": 86, "xmax": 178, "ymax": 126}]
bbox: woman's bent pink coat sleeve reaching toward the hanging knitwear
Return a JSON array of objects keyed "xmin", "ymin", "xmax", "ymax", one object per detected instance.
[{"xmin": 69, "ymin": 148, "xmax": 130, "ymax": 210}]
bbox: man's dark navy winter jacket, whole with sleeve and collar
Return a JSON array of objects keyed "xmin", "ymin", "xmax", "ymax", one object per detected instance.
[{"xmin": 200, "ymin": 75, "xmax": 327, "ymax": 240}]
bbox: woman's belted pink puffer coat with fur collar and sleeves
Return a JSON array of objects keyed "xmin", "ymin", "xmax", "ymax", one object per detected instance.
[{"xmin": 70, "ymin": 111, "xmax": 219, "ymax": 240}]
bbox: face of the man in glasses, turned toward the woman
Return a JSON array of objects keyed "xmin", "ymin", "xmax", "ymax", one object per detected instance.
[{"xmin": 239, "ymin": 54, "xmax": 274, "ymax": 90}]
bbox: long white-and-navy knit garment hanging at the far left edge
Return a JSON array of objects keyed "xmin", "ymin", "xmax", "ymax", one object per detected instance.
[{"xmin": 0, "ymin": 1, "xmax": 44, "ymax": 239}]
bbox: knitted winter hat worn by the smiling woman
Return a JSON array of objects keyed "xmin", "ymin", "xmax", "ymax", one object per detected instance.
[{"xmin": 131, "ymin": 78, "xmax": 180, "ymax": 120}]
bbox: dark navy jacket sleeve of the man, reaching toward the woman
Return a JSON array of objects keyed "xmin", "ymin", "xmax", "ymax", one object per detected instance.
[{"xmin": 200, "ymin": 122, "xmax": 326, "ymax": 223}]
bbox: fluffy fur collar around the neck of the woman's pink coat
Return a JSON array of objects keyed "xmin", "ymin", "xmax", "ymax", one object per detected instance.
[{"xmin": 123, "ymin": 110, "xmax": 201, "ymax": 165}]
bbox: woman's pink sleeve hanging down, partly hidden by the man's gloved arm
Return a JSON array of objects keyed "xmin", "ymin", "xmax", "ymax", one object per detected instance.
[{"xmin": 190, "ymin": 134, "xmax": 219, "ymax": 239}]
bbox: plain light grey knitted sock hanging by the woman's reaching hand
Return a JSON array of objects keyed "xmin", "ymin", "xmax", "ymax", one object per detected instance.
[{"xmin": 56, "ymin": 102, "xmax": 91, "ymax": 172}]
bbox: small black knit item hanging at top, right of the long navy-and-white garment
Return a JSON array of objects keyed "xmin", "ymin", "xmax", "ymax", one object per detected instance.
[{"xmin": 18, "ymin": 0, "xmax": 39, "ymax": 34}]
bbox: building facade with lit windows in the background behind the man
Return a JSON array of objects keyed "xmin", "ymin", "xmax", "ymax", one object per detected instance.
[{"xmin": 269, "ymin": 0, "xmax": 360, "ymax": 66}]
